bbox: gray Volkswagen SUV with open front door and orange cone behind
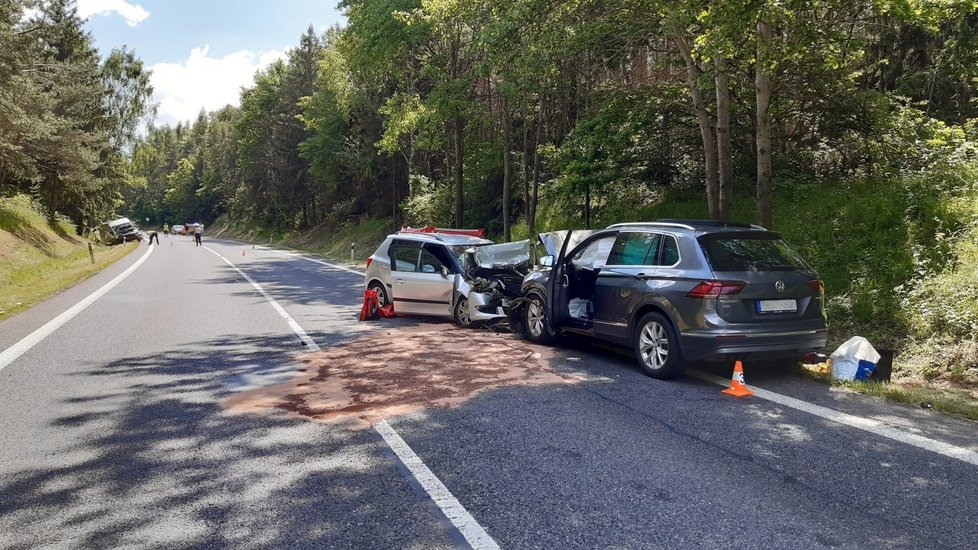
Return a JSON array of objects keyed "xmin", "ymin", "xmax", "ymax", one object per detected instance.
[{"xmin": 512, "ymin": 220, "xmax": 827, "ymax": 378}]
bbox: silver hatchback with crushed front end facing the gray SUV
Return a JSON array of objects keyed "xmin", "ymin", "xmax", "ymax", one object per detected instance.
[{"xmin": 364, "ymin": 232, "xmax": 531, "ymax": 327}]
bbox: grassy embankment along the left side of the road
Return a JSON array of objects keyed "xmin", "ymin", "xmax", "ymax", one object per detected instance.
[{"xmin": 0, "ymin": 195, "xmax": 138, "ymax": 319}]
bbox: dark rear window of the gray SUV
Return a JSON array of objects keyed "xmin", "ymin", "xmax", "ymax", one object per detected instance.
[{"xmin": 699, "ymin": 234, "xmax": 810, "ymax": 271}]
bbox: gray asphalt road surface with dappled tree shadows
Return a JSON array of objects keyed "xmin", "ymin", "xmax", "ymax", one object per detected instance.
[{"xmin": 0, "ymin": 237, "xmax": 978, "ymax": 549}]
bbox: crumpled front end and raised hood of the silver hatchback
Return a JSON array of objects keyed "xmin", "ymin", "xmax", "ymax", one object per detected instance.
[{"xmin": 456, "ymin": 240, "xmax": 532, "ymax": 323}]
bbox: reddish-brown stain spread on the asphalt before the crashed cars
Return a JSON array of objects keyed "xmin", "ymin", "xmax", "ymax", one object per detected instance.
[{"xmin": 223, "ymin": 324, "xmax": 580, "ymax": 429}]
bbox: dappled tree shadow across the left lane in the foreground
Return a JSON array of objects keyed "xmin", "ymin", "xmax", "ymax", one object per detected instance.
[{"xmin": 0, "ymin": 335, "xmax": 454, "ymax": 549}]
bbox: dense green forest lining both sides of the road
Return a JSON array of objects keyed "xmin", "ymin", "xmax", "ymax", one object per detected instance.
[{"xmin": 0, "ymin": 0, "xmax": 978, "ymax": 396}]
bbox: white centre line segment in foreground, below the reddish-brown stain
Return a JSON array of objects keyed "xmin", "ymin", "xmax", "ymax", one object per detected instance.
[{"xmin": 374, "ymin": 420, "xmax": 499, "ymax": 550}]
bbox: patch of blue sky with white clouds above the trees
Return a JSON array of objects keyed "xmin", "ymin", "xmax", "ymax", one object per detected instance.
[{"xmin": 77, "ymin": 0, "xmax": 343, "ymax": 126}]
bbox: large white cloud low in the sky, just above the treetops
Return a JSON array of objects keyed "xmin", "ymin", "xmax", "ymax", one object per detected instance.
[{"xmin": 150, "ymin": 46, "xmax": 286, "ymax": 124}]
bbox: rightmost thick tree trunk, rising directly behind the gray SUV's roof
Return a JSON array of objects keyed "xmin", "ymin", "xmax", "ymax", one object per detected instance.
[{"xmin": 754, "ymin": 20, "xmax": 772, "ymax": 229}]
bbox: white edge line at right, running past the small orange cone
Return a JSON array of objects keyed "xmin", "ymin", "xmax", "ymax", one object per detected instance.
[{"xmin": 686, "ymin": 369, "xmax": 978, "ymax": 466}]
